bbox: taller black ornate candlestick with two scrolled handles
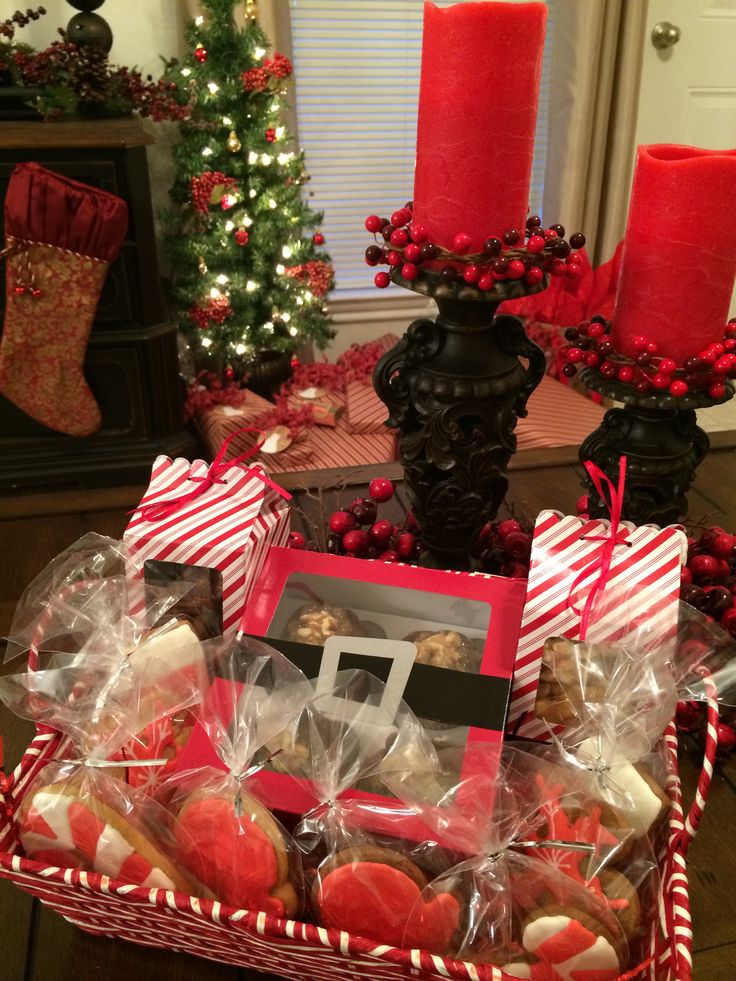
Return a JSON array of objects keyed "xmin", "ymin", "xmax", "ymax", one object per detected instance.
[{"xmin": 373, "ymin": 270, "xmax": 547, "ymax": 569}]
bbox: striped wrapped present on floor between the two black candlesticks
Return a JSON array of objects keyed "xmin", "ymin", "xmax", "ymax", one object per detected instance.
[{"xmin": 516, "ymin": 375, "xmax": 606, "ymax": 450}]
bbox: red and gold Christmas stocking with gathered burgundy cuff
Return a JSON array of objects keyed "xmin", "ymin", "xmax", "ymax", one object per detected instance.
[{"xmin": 0, "ymin": 163, "xmax": 128, "ymax": 436}]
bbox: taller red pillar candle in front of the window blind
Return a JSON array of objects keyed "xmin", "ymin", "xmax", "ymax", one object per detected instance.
[{"xmin": 414, "ymin": 0, "xmax": 547, "ymax": 252}]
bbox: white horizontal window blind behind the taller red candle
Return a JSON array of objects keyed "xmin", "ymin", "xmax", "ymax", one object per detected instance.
[{"xmin": 290, "ymin": 0, "xmax": 555, "ymax": 299}]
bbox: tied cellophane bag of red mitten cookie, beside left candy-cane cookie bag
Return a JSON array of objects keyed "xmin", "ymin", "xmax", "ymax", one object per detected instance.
[{"xmin": 157, "ymin": 636, "xmax": 312, "ymax": 918}]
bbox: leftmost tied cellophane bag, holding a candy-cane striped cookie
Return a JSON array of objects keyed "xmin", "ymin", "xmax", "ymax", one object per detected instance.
[{"xmin": 0, "ymin": 575, "xmax": 207, "ymax": 896}]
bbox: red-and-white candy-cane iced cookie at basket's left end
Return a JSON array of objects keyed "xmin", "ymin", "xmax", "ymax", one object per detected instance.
[{"xmin": 18, "ymin": 784, "xmax": 192, "ymax": 892}]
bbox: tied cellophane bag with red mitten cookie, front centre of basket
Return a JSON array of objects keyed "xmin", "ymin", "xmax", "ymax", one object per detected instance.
[{"xmin": 274, "ymin": 670, "xmax": 453, "ymax": 946}]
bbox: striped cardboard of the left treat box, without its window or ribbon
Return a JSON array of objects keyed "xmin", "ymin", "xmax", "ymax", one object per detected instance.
[{"xmin": 123, "ymin": 456, "xmax": 289, "ymax": 633}]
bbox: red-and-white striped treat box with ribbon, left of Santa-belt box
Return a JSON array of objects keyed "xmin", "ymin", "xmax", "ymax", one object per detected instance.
[{"xmin": 123, "ymin": 441, "xmax": 289, "ymax": 634}]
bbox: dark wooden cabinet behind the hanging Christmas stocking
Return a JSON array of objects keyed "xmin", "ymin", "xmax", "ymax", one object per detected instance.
[{"xmin": 0, "ymin": 119, "xmax": 194, "ymax": 490}]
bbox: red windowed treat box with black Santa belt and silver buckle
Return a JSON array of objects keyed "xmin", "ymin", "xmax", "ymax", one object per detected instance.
[{"xmin": 178, "ymin": 548, "xmax": 525, "ymax": 837}]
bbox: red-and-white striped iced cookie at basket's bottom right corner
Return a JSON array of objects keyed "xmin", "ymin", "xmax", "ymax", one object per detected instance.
[{"xmin": 504, "ymin": 906, "xmax": 621, "ymax": 981}]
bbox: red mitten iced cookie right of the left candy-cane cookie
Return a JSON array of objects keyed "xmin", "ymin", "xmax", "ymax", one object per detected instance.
[{"xmin": 175, "ymin": 791, "xmax": 301, "ymax": 917}]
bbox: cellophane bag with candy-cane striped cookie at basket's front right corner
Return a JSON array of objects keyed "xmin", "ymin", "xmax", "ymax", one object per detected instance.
[{"xmin": 385, "ymin": 746, "xmax": 629, "ymax": 981}]
